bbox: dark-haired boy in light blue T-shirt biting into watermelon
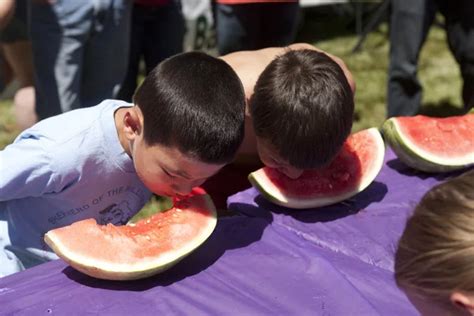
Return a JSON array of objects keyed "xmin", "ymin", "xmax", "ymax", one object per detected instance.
[{"xmin": 0, "ymin": 52, "xmax": 245, "ymax": 276}]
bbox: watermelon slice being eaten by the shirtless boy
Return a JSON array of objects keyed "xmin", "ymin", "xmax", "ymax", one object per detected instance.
[{"xmin": 249, "ymin": 128, "xmax": 385, "ymax": 209}]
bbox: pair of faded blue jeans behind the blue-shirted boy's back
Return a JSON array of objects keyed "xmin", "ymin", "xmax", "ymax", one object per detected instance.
[{"xmin": 30, "ymin": 0, "xmax": 131, "ymax": 119}]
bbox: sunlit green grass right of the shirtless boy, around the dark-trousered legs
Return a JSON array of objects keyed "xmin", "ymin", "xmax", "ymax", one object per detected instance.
[{"xmin": 303, "ymin": 12, "xmax": 462, "ymax": 131}]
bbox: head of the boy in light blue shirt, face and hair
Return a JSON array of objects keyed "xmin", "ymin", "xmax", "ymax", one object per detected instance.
[{"xmin": 124, "ymin": 52, "xmax": 245, "ymax": 196}]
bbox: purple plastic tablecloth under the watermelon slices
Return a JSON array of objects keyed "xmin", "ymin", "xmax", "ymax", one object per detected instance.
[{"xmin": 0, "ymin": 151, "xmax": 460, "ymax": 316}]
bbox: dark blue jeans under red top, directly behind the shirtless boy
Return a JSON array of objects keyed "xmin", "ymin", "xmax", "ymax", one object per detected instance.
[{"xmin": 215, "ymin": 2, "xmax": 299, "ymax": 55}]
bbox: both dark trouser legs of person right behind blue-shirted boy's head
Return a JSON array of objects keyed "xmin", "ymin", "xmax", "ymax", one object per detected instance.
[{"xmin": 118, "ymin": 1, "xmax": 184, "ymax": 102}]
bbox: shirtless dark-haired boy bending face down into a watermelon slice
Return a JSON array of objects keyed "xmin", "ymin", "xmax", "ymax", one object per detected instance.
[{"xmin": 202, "ymin": 43, "xmax": 355, "ymax": 207}]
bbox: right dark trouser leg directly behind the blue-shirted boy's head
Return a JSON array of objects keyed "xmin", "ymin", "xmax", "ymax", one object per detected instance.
[{"xmin": 144, "ymin": 1, "xmax": 184, "ymax": 74}]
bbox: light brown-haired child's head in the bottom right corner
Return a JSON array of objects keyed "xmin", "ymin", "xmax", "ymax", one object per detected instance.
[{"xmin": 395, "ymin": 170, "xmax": 474, "ymax": 316}]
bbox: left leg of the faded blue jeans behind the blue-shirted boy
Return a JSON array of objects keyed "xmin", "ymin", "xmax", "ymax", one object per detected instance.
[{"xmin": 30, "ymin": 0, "xmax": 93, "ymax": 119}]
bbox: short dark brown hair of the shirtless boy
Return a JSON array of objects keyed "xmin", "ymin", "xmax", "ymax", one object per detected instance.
[{"xmin": 250, "ymin": 50, "xmax": 354, "ymax": 169}]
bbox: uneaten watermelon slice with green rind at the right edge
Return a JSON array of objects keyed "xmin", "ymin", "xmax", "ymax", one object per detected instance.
[{"xmin": 382, "ymin": 114, "xmax": 474, "ymax": 172}]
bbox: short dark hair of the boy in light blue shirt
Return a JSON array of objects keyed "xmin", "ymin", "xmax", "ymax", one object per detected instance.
[{"xmin": 133, "ymin": 52, "xmax": 245, "ymax": 164}]
